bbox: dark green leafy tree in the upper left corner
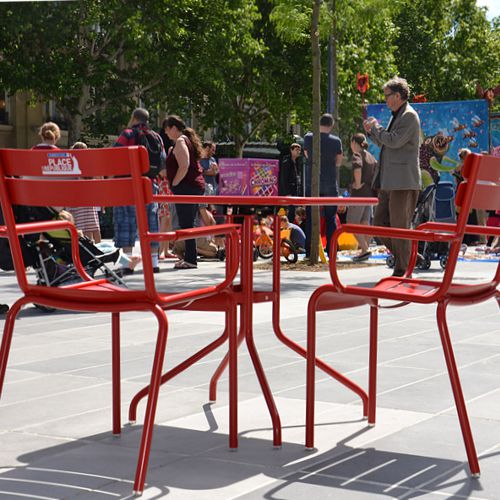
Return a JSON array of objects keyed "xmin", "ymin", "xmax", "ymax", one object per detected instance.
[{"xmin": 0, "ymin": 0, "xmax": 164, "ymax": 143}]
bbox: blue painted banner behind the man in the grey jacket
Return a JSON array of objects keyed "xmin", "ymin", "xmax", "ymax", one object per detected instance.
[{"xmin": 367, "ymin": 99, "xmax": 489, "ymax": 185}]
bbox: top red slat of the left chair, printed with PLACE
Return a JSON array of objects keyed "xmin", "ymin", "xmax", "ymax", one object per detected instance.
[{"xmin": 0, "ymin": 146, "xmax": 149, "ymax": 177}]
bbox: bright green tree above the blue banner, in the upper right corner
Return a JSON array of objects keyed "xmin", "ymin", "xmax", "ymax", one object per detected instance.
[{"xmin": 394, "ymin": 0, "xmax": 500, "ymax": 101}]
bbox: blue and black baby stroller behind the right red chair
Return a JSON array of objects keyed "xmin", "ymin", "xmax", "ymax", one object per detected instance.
[{"xmin": 387, "ymin": 180, "xmax": 456, "ymax": 269}]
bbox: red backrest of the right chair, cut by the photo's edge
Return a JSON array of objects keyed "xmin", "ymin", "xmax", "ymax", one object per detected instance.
[{"xmin": 443, "ymin": 153, "xmax": 500, "ymax": 285}]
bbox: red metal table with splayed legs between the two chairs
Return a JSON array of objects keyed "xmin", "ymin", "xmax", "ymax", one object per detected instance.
[{"xmin": 142, "ymin": 195, "xmax": 378, "ymax": 446}]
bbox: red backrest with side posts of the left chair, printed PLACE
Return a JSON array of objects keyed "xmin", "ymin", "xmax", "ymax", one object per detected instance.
[{"xmin": 0, "ymin": 146, "xmax": 154, "ymax": 292}]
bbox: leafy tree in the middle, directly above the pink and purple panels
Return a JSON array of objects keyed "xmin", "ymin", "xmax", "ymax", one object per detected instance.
[{"xmin": 191, "ymin": 0, "xmax": 309, "ymax": 156}]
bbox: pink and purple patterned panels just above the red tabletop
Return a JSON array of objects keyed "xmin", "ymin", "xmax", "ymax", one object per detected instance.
[{"xmin": 219, "ymin": 158, "xmax": 279, "ymax": 196}]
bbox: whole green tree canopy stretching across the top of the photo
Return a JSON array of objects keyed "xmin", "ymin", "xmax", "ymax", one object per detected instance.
[{"xmin": 0, "ymin": 0, "xmax": 500, "ymax": 151}]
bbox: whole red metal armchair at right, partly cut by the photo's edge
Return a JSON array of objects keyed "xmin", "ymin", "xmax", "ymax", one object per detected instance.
[{"xmin": 306, "ymin": 154, "xmax": 500, "ymax": 476}]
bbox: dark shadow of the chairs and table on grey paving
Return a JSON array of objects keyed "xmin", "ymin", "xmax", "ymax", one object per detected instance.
[{"xmin": 0, "ymin": 405, "xmax": 487, "ymax": 500}]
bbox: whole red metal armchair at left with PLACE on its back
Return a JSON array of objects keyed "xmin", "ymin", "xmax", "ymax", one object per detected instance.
[{"xmin": 0, "ymin": 146, "xmax": 239, "ymax": 494}]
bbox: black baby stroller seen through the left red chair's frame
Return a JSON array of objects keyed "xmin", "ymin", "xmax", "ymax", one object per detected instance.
[{"xmin": 0, "ymin": 207, "xmax": 125, "ymax": 311}]
